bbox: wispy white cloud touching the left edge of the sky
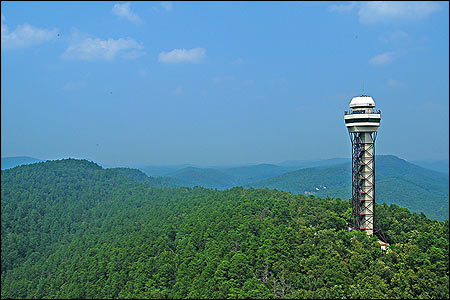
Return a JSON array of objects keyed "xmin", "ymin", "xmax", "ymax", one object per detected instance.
[{"xmin": 1, "ymin": 14, "xmax": 58, "ymax": 49}]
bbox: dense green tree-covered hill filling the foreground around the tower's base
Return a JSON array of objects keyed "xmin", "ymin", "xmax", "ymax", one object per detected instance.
[{"xmin": 1, "ymin": 159, "xmax": 449, "ymax": 299}]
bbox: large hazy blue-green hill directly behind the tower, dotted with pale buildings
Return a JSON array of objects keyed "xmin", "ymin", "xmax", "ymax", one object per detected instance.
[{"xmin": 248, "ymin": 155, "xmax": 449, "ymax": 220}]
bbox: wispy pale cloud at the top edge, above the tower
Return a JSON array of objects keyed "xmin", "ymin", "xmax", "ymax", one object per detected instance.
[{"xmin": 328, "ymin": 1, "xmax": 440, "ymax": 24}]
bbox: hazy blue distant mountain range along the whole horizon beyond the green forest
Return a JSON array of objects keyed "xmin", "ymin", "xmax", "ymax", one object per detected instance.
[{"xmin": 1, "ymin": 155, "xmax": 449, "ymax": 220}]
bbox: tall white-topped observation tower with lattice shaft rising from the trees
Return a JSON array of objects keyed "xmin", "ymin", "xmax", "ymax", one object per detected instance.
[{"xmin": 344, "ymin": 95, "xmax": 381, "ymax": 235}]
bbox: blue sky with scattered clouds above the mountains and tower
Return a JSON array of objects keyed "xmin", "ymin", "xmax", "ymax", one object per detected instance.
[{"xmin": 1, "ymin": 1, "xmax": 449, "ymax": 165}]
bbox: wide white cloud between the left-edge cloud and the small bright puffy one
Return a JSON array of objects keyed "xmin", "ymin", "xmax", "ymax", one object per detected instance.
[{"xmin": 62, "ymin": 37, "xmax": 144, "ymax": 60}]
